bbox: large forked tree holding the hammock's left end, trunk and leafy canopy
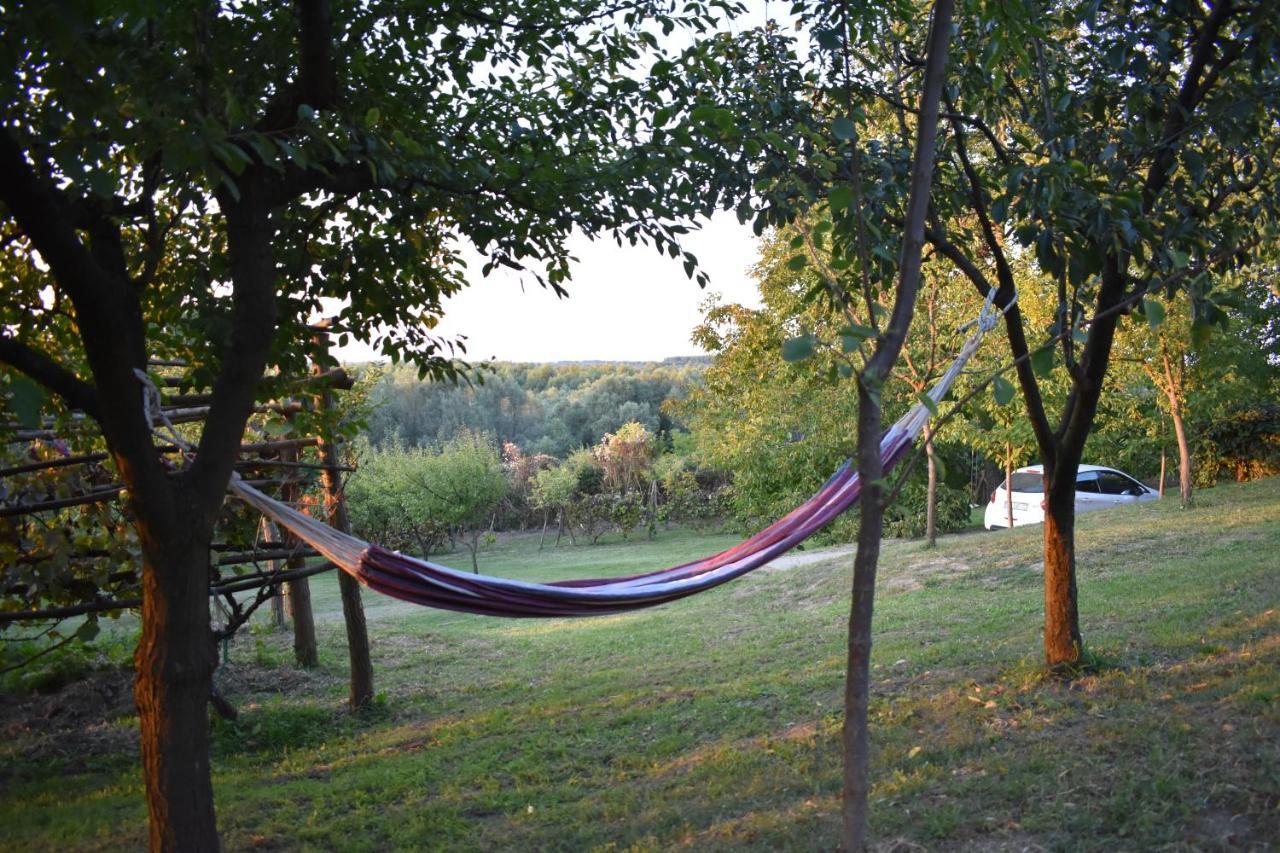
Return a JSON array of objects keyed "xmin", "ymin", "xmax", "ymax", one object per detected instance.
[{"xmin": 0, "ymin": 0, "xmax": 808, "ymax": 849}]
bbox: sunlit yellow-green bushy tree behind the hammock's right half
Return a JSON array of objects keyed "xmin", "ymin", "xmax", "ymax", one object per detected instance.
[{"xmin": 672, "ymin": 225, "xmax": 968, "ymax": 539}]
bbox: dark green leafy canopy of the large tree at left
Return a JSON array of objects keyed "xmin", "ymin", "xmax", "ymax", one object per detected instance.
[{"xmin": 0, "ymin": 3, "xmax": 804, "ymax": 402}]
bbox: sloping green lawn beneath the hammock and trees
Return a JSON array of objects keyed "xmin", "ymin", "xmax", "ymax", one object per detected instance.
[{"xmin": 0, "ymin": 479, "xmax": 1280, "ymax": 850}]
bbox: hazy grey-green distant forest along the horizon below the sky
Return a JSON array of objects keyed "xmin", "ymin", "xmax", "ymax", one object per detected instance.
[{"xmin": 369, "ymin": 357, "xmax": 709, "ymax": 459}]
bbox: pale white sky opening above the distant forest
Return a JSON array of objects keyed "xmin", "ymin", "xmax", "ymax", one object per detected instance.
[{"xmin": 335, "ymin": 211, "xmax": 760, "ymax": 362}]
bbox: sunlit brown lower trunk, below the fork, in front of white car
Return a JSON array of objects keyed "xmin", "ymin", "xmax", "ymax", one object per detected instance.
[{"xmin": 1044, "ymin": 466, "xmax": 1084, "ymax": 669}]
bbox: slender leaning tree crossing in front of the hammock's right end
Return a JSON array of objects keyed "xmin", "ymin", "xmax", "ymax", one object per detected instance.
[{"xmin": 762, "ymin": 0, "xmax": 955, "ymax": 850}]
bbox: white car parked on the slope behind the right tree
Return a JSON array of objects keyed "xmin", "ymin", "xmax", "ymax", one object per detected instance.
[{"xmin": 982, "ymin": 465, "xmax": 1160, "ymax": 530}]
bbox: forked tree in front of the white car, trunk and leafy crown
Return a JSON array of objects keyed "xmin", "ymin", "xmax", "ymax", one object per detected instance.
[{"xmin": 911, "ymin": 0, "xmax": 1280, "ymax": 667}]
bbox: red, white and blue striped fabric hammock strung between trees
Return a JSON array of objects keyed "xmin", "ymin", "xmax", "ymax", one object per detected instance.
[{"xmin": 229, "ymin": 296, "xmax": 1007, "ymax": 617}]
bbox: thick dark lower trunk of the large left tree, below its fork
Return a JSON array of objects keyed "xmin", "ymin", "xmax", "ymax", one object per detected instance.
[{"xmin": 133, "ymin": 527, "xmax": 220, "ymax": 852}]
